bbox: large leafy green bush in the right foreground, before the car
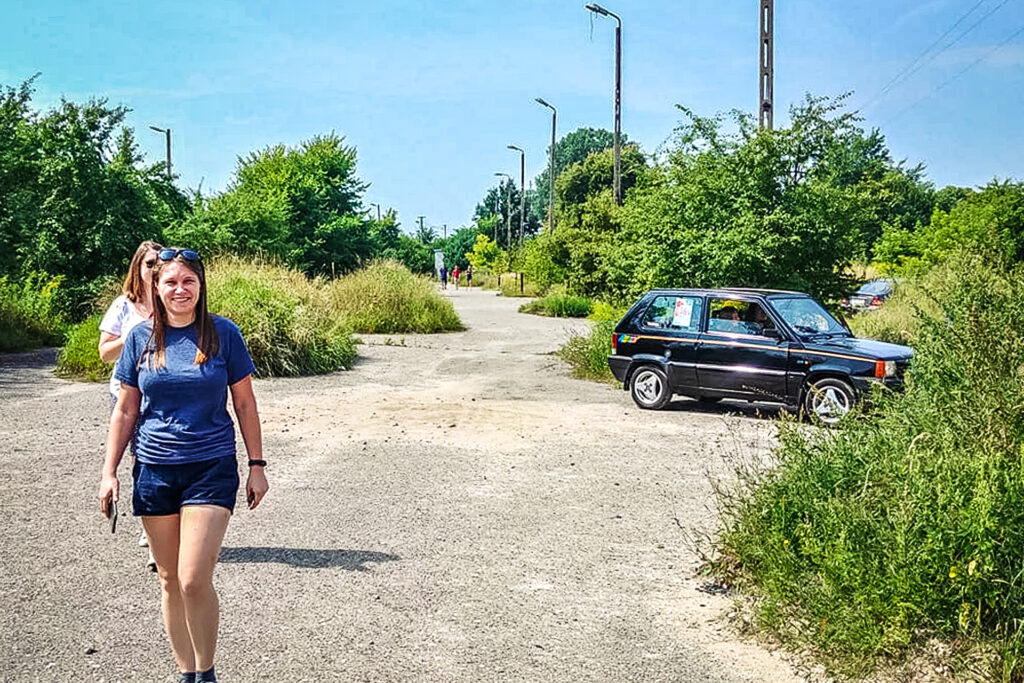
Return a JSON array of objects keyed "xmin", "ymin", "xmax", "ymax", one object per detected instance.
[{"xmin": 718, "ymin": 253, "xmax": 1024, "ymax": 681}]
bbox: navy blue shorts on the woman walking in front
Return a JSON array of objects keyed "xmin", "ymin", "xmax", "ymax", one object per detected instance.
[{"xmin": 132, "ymin": 456, "xmax": 239, "ymax": 517}]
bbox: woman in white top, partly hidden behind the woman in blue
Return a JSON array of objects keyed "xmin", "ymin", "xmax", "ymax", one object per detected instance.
[{"xmin": 99, "ymin": 240, "xmax": 163, "ymax": 571}]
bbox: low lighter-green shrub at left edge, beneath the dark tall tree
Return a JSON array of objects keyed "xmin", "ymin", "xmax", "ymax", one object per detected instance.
[{"xmin": 0, "ymin": 274, "xmax": 66, "ymax": 352}]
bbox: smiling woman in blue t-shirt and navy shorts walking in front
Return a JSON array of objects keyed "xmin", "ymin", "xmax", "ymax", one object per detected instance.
[{"xmin": 99, "ymin": 249, "xmax": 268, "ymax": 681}]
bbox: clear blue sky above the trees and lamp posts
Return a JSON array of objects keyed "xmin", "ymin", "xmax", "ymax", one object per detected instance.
[{"xmin": 0, "ymin": 0, "xmax": 1024, "ymax": 230}]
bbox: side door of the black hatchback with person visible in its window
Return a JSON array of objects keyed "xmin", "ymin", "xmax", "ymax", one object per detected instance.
[{"xmin": 696, "ymin": 297, "xmax": 790, "ymax": 402}]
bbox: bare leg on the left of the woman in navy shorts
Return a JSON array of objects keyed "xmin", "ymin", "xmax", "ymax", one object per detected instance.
[{"xmin": 142, "ymin": 515, "xmax": 196, "ymax": 672}]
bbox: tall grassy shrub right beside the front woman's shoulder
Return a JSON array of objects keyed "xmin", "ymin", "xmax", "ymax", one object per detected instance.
[{"xmin": 207, "ymin": 258, "xmax": 355, "ymax": 377}]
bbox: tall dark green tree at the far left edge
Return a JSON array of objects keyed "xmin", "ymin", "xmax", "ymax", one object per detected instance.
[{"xmin": 0, "ymin": 80, "xmax": 186, "ymax": 317}]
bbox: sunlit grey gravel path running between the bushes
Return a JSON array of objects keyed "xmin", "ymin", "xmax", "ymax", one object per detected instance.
[{"xmin": 0, "ymin": 290, "xmax": 815, "ymax": 682}]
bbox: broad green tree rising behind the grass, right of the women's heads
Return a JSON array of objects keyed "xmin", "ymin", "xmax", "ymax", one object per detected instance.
[{"xmin": 170, "ymin": 133, "xmax": 373, "ymax": 275}]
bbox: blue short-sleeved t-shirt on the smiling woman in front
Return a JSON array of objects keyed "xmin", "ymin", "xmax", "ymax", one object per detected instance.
[{"xmin": 114, "ymin": 315, "xmax": 256, "ymax": 465}]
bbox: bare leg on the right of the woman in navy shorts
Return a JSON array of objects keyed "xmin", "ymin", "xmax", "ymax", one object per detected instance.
[{"xmin": 177, "ymin": 505, "xmax": 231, "ymax": 671}]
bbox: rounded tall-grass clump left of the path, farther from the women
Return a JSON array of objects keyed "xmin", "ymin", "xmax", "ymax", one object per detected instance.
[{"xmin": 327, "ymin": 261, "xmax": 463, "ymax": 334}]
